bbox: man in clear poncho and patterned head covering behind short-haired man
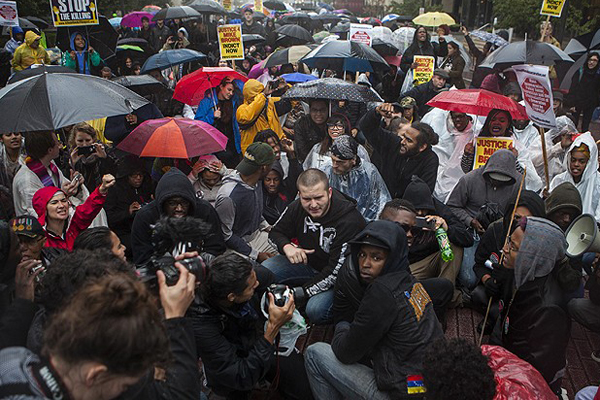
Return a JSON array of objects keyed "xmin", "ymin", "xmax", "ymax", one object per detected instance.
[{"xmin": 323, "ymin": 135, "xmax": 392, "ymax": 221}]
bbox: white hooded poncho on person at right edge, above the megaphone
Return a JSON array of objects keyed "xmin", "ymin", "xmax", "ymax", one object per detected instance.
[{"xmin": 550, "ymin": 132, "xmax": 600, "ymax": 221}]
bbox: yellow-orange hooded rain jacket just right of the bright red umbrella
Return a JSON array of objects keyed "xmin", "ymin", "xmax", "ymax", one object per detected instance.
[{"xmin": 236, "ymin": 79, "xmax": 283, "ymax": 154}]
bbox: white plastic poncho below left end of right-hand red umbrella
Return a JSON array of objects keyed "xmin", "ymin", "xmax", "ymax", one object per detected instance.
[{"xmin": 421, "ymin": 108, "xmax": 475, "ymax": 203}]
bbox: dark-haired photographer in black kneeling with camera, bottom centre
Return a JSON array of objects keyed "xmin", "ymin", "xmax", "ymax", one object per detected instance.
[{"xmin": 190, "ymin": 254, "xmax": 312, "ymax": 399}]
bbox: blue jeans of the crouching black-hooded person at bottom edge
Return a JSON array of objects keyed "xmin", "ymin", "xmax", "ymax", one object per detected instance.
[{"xmin": 304, "ymin": 343, "xmax": 390, "ymax": 400}]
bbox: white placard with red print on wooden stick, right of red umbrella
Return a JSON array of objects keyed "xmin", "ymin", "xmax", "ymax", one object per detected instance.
[{"xmin": 512, "ymin": 65, "xmax": 556, "ymax": 128}]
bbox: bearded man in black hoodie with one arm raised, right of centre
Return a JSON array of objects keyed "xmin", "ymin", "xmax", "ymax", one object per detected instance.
[{"xmin": 359, "ymin": 103, "xmax": 439, "ymax": 198}]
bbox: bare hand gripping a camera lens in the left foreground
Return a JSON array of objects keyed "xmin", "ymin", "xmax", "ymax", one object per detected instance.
[{"xmin": 156, "ymin": 262, "xmax": 196, "ymax": 319}]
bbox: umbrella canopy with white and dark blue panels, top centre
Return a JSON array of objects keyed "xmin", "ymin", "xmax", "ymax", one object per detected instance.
[{"xmin": 300, "ymin": 40, "xmax": 389, "ymax": 72}]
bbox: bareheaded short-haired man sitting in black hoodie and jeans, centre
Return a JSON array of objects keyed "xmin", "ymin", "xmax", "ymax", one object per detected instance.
[{"xmin": 263, "ymin": 168, "xmax": 365, "ymax": 324}]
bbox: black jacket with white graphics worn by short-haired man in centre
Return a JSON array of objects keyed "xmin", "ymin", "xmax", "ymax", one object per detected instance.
[{"xmin": 269, "ymin": 189, "xmax": 366, "ymax": 296}]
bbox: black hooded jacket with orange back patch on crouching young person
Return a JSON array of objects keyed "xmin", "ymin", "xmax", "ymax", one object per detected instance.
[{"xmin": 331, "ymin": 221, "xmax": 444, "ymax": 398}]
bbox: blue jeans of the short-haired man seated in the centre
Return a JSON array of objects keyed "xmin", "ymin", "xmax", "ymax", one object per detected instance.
[{"xmin": 262, "ymin": 254, "xmax": 334, "ymax": 325}]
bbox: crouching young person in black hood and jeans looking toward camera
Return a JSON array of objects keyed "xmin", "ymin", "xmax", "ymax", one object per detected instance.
[{"xmin": 305, "ymin": 221, "xmax": 443, "ymax": 399}]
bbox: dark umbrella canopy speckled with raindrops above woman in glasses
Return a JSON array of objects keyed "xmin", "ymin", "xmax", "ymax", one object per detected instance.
[{"xmin": 283, "ymin": 78, "xmax": 383, "ymax": 103}]
